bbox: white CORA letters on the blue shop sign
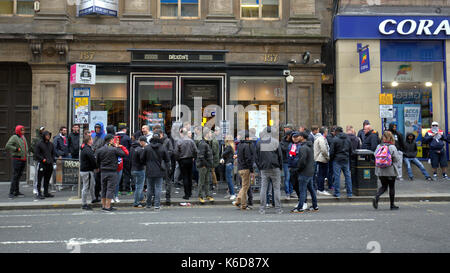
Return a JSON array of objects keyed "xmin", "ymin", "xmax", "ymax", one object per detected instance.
[{"xmin": 378, "ymin": 19, "xmax": 450, "ymax": 36}]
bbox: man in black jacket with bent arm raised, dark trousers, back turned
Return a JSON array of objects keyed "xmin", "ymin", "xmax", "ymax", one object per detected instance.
[{"xmin": 95, "ymin": 134, "xmax": 128, "ymax": 212}]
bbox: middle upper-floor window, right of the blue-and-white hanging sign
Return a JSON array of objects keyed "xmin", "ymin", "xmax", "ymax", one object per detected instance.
[{"xmin": 160, "ymin": 0, "xmax": 200, "ymax": 18}]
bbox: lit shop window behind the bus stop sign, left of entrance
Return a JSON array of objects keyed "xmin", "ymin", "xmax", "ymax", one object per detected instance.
[{"xmin": 89, "ymin": 75, "xmax": 129, "ymax": 133}]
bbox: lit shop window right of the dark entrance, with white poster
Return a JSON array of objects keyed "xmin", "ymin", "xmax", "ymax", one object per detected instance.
[{"xmin": 227, "ymin": 77, "xmax": 286, "ymax": 137}]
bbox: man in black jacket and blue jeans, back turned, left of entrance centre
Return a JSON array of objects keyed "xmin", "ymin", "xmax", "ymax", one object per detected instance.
[{"xmin": 141, "ymin": 130, "xmax": 170, "ymax": 211}]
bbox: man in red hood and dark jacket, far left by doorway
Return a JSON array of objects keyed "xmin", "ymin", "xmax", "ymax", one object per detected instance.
[{"xmin": 5, "ymin": 125, "xmax": 28, "ymax": 199}]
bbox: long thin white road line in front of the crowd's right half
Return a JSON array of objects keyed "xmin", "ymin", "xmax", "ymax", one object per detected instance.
[{"xmin": 140, "ymin": 219, "xmax": 375, "ymax": 226}]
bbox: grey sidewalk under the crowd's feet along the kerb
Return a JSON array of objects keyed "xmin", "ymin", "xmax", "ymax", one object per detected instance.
[{"xmin": 0, "ymin": 175, "xmax": 450, "ymax": 210}]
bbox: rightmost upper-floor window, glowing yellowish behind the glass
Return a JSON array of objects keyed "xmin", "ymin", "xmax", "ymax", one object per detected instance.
[{"xmin": 241, "ymin": 0, "xmax": 280, "ymax": 18}]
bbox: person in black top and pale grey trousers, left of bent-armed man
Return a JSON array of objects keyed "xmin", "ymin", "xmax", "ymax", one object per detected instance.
[{"xmin": 80, "ymin": 135, "xmax": 97, "ymax": 210}]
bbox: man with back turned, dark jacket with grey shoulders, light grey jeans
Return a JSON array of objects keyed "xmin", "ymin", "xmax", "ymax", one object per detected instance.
[{"xmin": 255, "ymin": 127, "xmax": 283, "ymax": 214}]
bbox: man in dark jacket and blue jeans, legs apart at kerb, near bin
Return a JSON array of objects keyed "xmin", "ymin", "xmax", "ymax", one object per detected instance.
[{"xmin": 291, "ymin": 132, "xmax": 319, "ymax": 213}]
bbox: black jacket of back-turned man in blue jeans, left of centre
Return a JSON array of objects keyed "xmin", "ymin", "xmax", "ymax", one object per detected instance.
[{"xmin": 141, "ymin": 138, "xmax": 170, "ymax": 177}]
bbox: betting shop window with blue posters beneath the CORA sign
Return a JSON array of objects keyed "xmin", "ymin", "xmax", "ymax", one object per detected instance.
[{"xmin": 382, "ymin": 62, "xmax": 445, "ymax": 158}]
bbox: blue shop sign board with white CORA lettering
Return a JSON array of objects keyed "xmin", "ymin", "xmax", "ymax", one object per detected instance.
[{"xmin": 334, "ymin": 15, "xmax": 450, "ymax": 40}]
